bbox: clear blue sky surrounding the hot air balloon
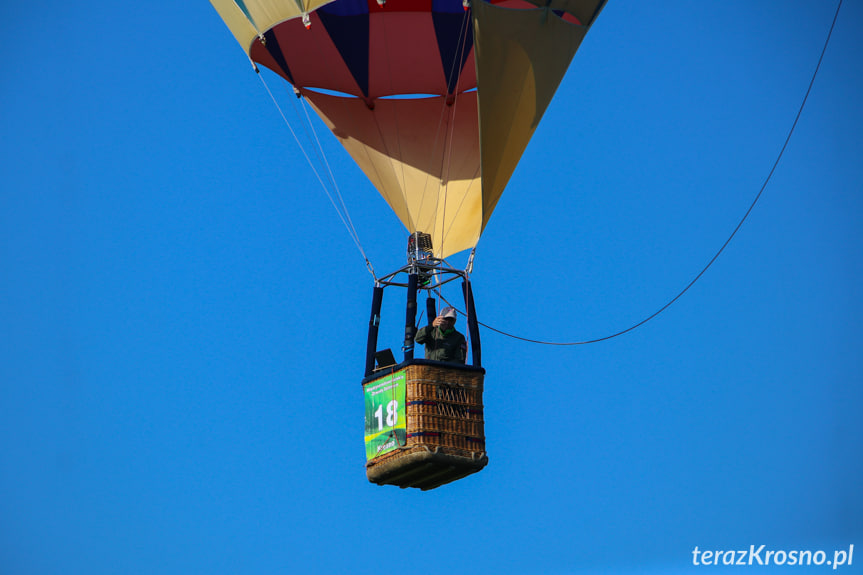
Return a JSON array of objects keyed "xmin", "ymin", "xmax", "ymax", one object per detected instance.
[{"xmin": 0, "ymin": 0, "xmax": 863, "ymax": 575}]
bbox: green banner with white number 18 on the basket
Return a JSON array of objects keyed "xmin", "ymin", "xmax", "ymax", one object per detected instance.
[{"xmin": 363, "ymin": 370, "xmax": 407, "ymax": 461}]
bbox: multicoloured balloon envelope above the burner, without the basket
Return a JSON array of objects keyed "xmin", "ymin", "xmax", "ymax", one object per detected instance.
[{"xmin": 211, "ymin": 0, "xmax": 604, "ymax": 257}]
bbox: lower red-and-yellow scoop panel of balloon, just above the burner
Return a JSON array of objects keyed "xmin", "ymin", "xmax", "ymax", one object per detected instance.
[{"xmin": 303, "ymin": 90, "xmax": 483, "ymax": 257}]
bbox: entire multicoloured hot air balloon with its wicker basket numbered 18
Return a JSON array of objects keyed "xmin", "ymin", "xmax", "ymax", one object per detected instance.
[{"xmin": 210, "ymin": 0, "xmax": 605, "ymax": 489}]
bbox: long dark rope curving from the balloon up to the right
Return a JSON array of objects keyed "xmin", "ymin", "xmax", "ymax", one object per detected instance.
[{"xmin": 441, "ymin": 0, "xmax": 842, "ymax": 346}]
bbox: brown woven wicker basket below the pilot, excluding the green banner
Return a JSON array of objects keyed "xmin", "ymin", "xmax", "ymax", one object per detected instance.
[{"xmin": 363, "ymin": 360, "xmax": 488, "ymax": 490}]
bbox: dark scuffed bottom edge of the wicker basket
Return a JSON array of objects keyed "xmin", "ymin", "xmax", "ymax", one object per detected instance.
[{"xmin": 366, "ymin": 447, "xmax": 488, "ymax": 491}]
